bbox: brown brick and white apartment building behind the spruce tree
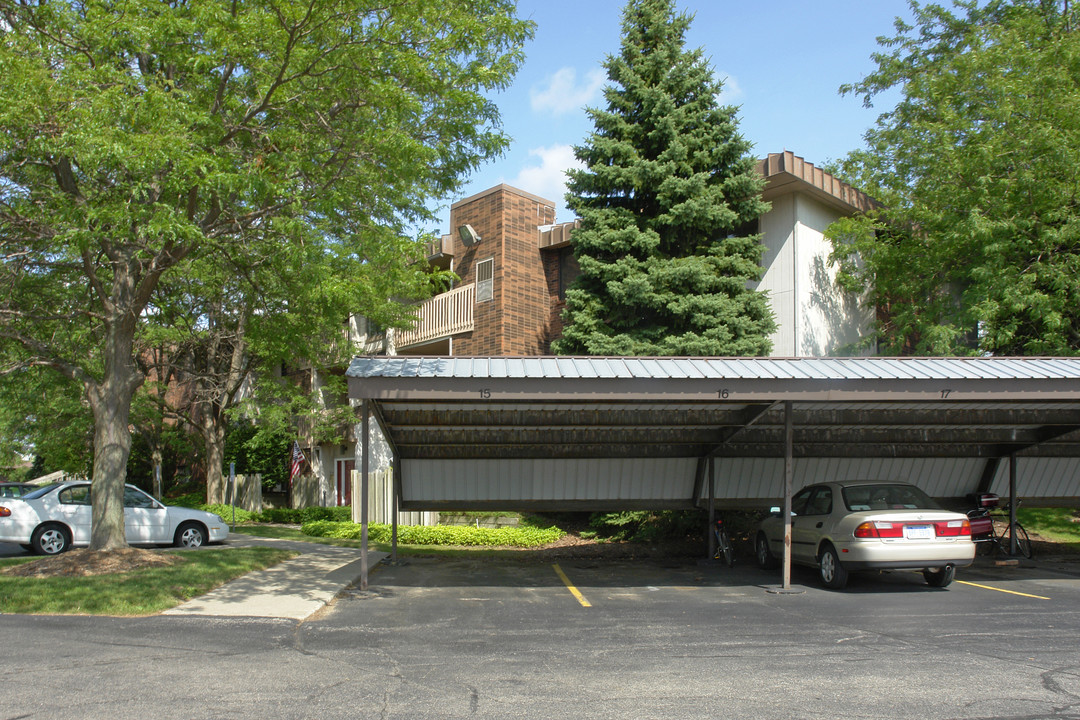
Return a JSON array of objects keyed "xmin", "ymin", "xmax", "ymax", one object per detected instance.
[{"xmin": 295, "ymin": 151, "xmax": 876, "ymax": 515}]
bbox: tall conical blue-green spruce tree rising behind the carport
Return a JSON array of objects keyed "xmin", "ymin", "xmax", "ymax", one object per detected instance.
[{"xmin": 553, "ymin": 0, "xmax": 774, "ymax": 355}]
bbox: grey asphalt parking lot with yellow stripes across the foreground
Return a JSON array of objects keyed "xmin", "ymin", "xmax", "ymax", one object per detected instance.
[{"xmin": 0, "ymin": 546, "xmax": 1080, "ymax": 719}]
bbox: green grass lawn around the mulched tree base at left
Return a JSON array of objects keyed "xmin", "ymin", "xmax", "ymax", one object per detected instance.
[{"xmin": 0, "ymin": 547, "xmax": 297, "ymax": 615}]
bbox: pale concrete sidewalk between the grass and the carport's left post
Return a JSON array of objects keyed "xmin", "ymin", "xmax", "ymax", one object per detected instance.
[{"xmin": 162, "ymin": 535, "xmax": 388, "ymax": 620}]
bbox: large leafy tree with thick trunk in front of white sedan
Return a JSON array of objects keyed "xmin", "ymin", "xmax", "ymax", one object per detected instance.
[{"xmin": 0, "ymin": 0, "xmax": 531, "ymax": 549}]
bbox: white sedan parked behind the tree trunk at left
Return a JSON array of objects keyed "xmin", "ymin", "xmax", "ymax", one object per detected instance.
[{"xmin": 0, "ymin": 481, "xmax": 229, "ymax": 555}]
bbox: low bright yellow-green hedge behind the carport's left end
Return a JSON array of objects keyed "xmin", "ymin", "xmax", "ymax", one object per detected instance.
[{"xmin": 300, "ymin": 520, "xmax": 566, "ymax": 547}]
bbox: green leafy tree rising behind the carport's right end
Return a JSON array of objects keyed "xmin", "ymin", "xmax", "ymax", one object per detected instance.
[{"xmin": 829, "ymin": 0, "xmax": 1080, "ymax": 355}]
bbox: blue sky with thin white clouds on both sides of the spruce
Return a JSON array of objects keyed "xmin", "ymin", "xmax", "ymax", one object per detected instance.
[{"xmin": 430, "ymin": 0, "xmax": 910, "ymax": 232}]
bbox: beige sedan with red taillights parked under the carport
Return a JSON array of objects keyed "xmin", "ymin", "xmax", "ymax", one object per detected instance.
[{"xmin": 754, "ymin": 480, "xmax": 975, "ymax": 588}]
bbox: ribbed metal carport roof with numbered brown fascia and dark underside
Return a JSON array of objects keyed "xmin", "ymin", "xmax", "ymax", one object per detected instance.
[{"xmin": 347, "ymin": 356, "xmax": 1080, "ymax": 468}]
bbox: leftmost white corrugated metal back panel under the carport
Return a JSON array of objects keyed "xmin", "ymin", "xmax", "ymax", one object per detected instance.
[{"xmin": 402, "ymin": 458, "xmax": 698, "ymax": 505}]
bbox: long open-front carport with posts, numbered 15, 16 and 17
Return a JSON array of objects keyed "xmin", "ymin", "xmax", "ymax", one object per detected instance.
[{"xmin": 347, "ymin": 356, "xmax": 1080, "ymax": 585}]
